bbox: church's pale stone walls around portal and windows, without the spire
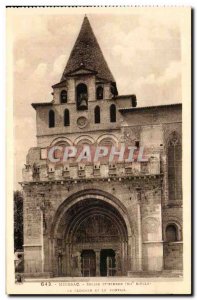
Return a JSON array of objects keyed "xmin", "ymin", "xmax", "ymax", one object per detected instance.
[{"xmin": 23, "ymin": 76, "xmax": 182, "ymax": 275}]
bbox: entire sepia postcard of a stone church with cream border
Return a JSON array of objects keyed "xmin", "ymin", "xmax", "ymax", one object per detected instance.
[{"xmin": 6, "ymin": 7, "xmax": 191, "ymax": 295}]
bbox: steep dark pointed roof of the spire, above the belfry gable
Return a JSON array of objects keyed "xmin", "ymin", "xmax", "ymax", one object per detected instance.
[{"xmin": 61, "ymin": 16, "xmax": 115, "ymax": 82}]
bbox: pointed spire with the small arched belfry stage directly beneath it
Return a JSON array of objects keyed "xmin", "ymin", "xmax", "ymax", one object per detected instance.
[{"xmin": 53, "ymin": 16, "xmax": 118, "ymax": 111}]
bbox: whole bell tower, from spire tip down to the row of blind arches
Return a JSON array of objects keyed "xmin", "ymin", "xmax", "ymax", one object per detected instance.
[{"xmin": 32, "ymin": 16, "xmax": 136, "ymax": 148}]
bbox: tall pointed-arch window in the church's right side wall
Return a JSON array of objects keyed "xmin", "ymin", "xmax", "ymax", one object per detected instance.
[{"xmin": 168, "ymin": 132, "xmax": 182, "ymax": 200}]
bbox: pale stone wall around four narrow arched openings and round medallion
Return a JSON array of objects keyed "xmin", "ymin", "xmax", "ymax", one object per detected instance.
[{"xmin": 37, "ymin": 100, "xmax": 121, "ymax": 145}]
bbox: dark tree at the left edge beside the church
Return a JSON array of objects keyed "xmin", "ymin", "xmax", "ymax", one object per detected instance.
[{"xmin": 14, "ymin": 191, "xmax": 23, "ymax": 251}]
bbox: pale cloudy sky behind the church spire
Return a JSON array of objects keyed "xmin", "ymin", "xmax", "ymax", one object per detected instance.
[{"xmin": 12, "ymin": 9, "xmax": 182, "ymax": 189}]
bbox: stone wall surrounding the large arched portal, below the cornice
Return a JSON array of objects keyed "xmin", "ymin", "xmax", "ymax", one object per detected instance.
[{"xmin": 21, "ymin": 172, "xmax": 162, "ymax": 273}]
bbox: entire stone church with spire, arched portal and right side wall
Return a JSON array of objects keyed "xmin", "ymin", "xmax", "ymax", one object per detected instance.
[{"xmin": 21, "ymin": 17, "xmax": 183, "ymax": 277}]
